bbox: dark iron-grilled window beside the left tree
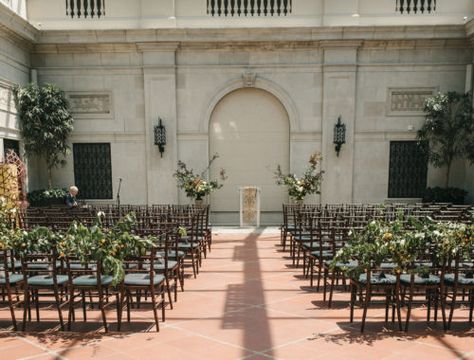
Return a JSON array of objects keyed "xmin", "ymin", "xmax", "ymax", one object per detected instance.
[{"xmin": 73, "ymin": 143, "xmax": 113, "ymax": 199}]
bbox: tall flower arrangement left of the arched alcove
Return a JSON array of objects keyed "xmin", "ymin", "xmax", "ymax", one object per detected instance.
[{"xmin": 173, "ymin": 154, "xmax": 227, "ymax": 201}]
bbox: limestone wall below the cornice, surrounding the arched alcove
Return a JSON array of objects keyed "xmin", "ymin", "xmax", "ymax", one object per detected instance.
[{"xmin": 25, "ymin": 26, "xmax": 472, "ymax": 208}]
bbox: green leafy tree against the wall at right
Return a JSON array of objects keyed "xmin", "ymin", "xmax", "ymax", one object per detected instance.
[{"xmin": 417, "ymin": 91, "xmax": 474, "ymax": 187}]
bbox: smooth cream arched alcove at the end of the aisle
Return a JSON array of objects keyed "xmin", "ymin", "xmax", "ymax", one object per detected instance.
[{"xmin": 209, "ymin": 88, "xmax": 290, "ymax": 224}]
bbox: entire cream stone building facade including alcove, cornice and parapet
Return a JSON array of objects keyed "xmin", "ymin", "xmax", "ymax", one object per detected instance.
[{"xmin": 0, "ymin": 0, "xmax": 474, "ymax": 223}]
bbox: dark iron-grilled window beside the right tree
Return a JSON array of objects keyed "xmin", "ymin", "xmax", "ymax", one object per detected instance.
[{"xmin": 388, "ymin": 141, "xmax": 428, "ymax": 198}]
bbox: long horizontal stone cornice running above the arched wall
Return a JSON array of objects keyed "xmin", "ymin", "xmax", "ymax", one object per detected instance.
[{"xmin": 34, "ymin": 25, "xmax": 466, "ymax": 44}]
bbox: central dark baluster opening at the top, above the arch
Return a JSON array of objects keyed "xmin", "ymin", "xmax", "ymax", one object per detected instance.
[{"xmin": 207, "ymin": 0, "xmax": 293, "ymax": 16}]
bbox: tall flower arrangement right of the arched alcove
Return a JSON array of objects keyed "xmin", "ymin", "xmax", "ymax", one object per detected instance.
[{"xmin": 275, "ymin": 153, "xmax": 324, "ymax": 202}]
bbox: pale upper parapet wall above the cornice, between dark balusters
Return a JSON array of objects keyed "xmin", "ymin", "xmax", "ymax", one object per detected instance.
[{"xmin": 27, "ymin": 0, "xmax": 474, "ymax": 30}]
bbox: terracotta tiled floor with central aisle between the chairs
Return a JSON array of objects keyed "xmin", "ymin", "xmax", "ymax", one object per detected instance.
[{"xmin": 0, "ymin": 229, "xmax": 474, "ymax": 360}]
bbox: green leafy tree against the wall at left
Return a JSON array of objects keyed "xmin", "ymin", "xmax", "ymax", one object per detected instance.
[{"xmin": 13, "ymin": 84, "xmax": 73, "ymax": 189}]
